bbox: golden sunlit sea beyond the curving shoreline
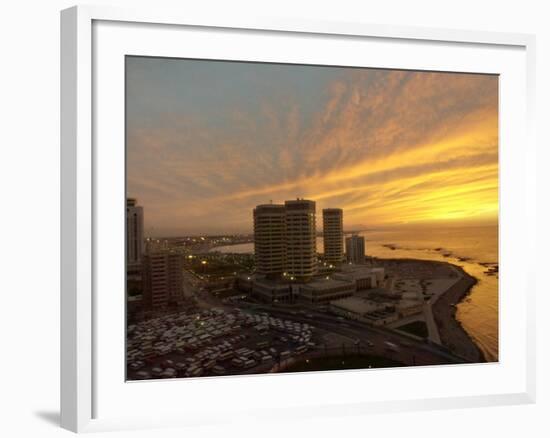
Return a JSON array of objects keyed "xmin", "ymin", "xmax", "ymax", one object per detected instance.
[{"xmin": 213, "ymin": 225, "xmax": 499, "ymax": 362}]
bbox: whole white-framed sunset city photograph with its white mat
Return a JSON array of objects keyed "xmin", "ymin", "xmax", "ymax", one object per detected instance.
[{"xmin": 61, "ymin": 7, "xmax": 535, "ymax": 431}]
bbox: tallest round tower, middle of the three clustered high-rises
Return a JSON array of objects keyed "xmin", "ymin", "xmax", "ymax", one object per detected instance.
[{"xmin": 285, "ymin": 199, "xmax": 317, "ymax": 280}]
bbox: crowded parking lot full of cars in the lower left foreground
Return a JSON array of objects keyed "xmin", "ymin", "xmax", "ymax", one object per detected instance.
[{"xmin": 127, "ymin": 308, "xmax": 318, "ymax": 380}]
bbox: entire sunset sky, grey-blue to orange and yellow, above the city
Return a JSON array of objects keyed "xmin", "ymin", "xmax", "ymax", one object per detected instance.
[{"xmin": 126, "ymin": 57, "xmax": 498, "ymax": 236}]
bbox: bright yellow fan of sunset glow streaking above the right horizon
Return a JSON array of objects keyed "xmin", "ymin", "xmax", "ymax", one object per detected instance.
[{"xmin": 210, "ymin": 113, "xmax": 498, "ymax": 224}]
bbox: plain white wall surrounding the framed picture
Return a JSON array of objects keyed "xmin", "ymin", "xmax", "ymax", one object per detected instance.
[{"xmin": 0, "ymin": 0, "xmax": 550, "ymax": 438}]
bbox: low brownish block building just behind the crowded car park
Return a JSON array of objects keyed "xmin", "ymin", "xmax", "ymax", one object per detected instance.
[{"xmin": 143, "ymin": 251, "xmax": 183, "ymax": 310}]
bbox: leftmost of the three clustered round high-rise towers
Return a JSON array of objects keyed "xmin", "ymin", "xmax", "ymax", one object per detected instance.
[{"xmin": 253, "ymin": 204, "xmax": 286, "ymax": 277}]
